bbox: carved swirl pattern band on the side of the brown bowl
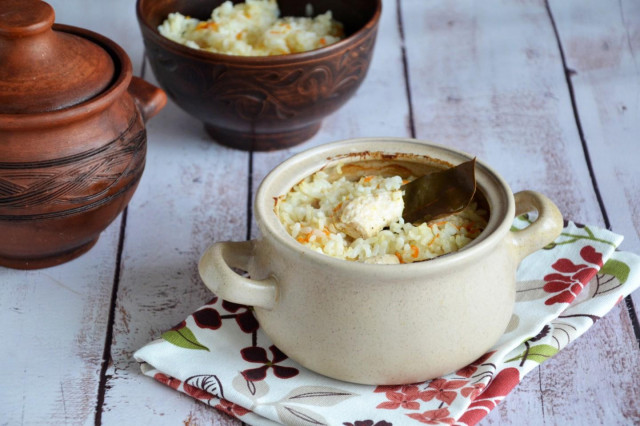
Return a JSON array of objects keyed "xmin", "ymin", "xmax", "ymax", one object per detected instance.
[{"xmin": 147, "ymin": 33, "xmax": 375, "ymax": 122}]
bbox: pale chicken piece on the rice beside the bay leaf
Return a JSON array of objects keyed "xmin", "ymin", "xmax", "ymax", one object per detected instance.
[{"xmin": 338, "ymin": 190, "xmax": 404, "ymax": 239}]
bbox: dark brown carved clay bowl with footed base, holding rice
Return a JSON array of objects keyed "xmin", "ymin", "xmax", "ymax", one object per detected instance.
[{"xmin": 137, "ymin": 0, "xmax": 382, "ymax": 150}]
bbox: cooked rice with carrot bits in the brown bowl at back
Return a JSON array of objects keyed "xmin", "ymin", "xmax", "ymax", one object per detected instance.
[{"xmin": 158, "ymin": 0, "xmax": 344, "ymax": 56}]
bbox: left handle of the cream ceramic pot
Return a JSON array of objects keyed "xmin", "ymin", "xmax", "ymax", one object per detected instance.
[{"xmin": 198, "ymin": 240, "xmax": 277, "ymax": 309}]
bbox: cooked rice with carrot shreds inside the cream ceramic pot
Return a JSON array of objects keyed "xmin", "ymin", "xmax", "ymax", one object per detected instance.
[{"xmin": 276, "ymin": 169, "xmax": 486, "ymax": 263}]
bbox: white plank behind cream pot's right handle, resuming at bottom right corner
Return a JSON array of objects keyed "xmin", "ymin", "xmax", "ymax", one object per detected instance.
[{"xmin": 401, "ymin": 0, "xmax": 640, "ymax": 424}]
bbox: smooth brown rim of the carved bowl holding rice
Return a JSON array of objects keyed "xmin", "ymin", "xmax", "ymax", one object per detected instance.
[{"xmin": 136, "ymin": 0, "xmax": 382, "ymax": 66}]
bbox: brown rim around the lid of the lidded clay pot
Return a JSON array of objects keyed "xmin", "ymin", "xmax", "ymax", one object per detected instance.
[{"xmin": 0, "ymin": 24, "xmax": 133, "ymax": 130}]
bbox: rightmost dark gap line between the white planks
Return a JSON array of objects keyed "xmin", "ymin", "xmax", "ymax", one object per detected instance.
[{"xmin": 544, "ymin": 0, "xmax": 640, "ymax": 346}]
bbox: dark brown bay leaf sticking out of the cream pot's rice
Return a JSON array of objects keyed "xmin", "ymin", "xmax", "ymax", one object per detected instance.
[{"xmin": 400, "ymin": 158, "xmax": 476, "ymax": 223}]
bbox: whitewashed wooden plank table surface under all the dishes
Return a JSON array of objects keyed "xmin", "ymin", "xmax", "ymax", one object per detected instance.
[{"xmin": 0, "ymin": 0, "xmax": 640, "ymax": 425}]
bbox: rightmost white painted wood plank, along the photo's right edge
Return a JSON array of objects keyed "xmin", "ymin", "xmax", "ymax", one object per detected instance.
[{"xmin": 550, "ymin": 1, "xmax": 640, "ymax": 312}]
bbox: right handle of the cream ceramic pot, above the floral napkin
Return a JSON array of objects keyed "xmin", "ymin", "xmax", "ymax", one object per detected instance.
[{"xmin": 510, "ymin": 191, "xmax": 564, "ymax": 262}]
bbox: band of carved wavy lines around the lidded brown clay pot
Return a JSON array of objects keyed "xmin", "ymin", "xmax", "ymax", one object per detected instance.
[{"xmin": 0, "ymin": 114, "xmax": 147, "ymax": 221}]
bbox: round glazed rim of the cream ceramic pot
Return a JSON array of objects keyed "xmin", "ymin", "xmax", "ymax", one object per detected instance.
[{"xmin": 254, "ymin": 137, "xmax": 515, "ymax": 278}]
